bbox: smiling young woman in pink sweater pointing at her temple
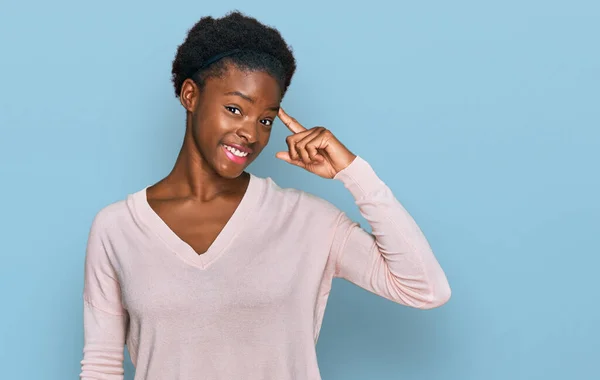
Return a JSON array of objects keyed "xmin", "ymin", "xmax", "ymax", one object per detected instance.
[{"xmin": 81, "ymin": 12, "xmax": 450, "ymax": 380}]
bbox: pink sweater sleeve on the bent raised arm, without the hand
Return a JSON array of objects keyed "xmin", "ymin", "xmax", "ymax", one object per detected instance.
[{"xmin": 331, "ymin": 157, "xmax": 451, "ymax": 309}]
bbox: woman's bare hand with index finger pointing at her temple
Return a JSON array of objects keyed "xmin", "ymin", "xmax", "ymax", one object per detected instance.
[{"xmin": 276, "ymin": 108, "xmax": 356, "ymax": 179}]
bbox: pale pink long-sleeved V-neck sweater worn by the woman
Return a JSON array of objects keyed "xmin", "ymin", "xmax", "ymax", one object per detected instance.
[{"xmin": 81, "ymin": 157, "xmax": 450, "ymax": 380}]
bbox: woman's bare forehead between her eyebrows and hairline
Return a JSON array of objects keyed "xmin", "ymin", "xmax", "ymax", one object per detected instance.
[{"xmin": 206, "ymin": 65, "xmax": 281, "ymax": 103}]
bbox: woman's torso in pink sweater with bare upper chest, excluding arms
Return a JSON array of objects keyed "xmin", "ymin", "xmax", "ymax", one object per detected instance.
[{"xmin": 90, "ymin": 179, "xmax": 339, "ymax": 379}]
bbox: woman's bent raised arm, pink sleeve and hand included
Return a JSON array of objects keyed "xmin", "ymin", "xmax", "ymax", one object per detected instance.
[{"xmin": 277, "ymin": 109, "xmax": 451, "ymax": 309}]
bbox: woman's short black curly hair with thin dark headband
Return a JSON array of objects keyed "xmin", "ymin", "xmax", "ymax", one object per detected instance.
[{"xmin": 171, "ymin": 11, "xmax": 296, "ymax": 97}]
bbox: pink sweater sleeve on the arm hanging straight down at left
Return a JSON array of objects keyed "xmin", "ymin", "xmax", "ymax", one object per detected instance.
[{"xmin": 80, "ymin": 215, "xmax": 128, "ymax": 380}]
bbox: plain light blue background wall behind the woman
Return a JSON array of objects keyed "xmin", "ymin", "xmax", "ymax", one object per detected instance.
[{"xmin": 0, "ymin": 0, "xmax": 600, "ymax": 380}]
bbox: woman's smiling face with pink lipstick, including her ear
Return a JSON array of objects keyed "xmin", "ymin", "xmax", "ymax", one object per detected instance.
[{"xmin": 181, "ymin": 66, "xmax": 281, "ymax": 178}]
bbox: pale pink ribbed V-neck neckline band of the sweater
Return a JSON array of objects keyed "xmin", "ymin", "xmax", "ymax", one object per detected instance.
[{"xmin": 131, "ymin": 174, "xmax": 264, "ymax": 269}]
